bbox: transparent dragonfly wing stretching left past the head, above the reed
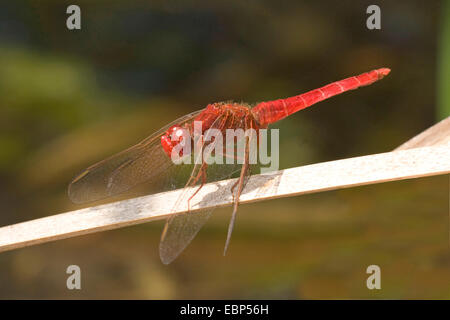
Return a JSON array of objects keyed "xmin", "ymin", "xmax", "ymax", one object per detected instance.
[{"xmin": 68, "ymin": 110, "xmax": 201, "ymax": 203}]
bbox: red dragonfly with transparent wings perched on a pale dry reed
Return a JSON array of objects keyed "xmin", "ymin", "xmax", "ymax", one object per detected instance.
[{"xmin": 69, "ymin": 68, "xmax": 390, "ymax": 264}]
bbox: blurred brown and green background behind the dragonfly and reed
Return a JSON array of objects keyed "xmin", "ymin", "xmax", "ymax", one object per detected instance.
[{"xmin": 0, "ymin": 0, "xmax": 450, "ymax": 299}]
